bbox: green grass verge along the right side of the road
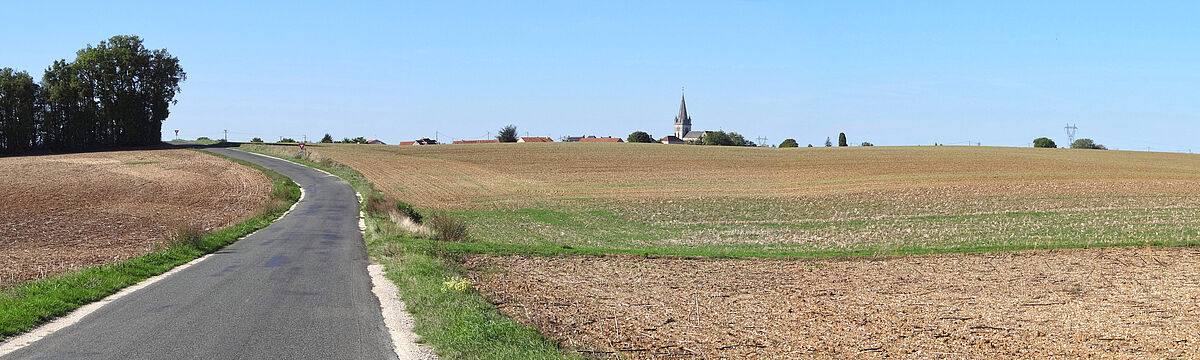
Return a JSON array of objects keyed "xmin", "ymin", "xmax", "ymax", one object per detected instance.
[{"xmin": 240, "ymin": 145, "xmax": 578, "ymax": 359}]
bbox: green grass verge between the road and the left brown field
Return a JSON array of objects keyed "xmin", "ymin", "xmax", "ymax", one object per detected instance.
[{"xmin": 0, "ymin": 151, "xmax": 300, "ymax": 341}]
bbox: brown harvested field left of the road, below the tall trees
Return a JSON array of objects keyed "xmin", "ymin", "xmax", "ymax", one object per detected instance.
[{"xmin": 0, "ymin": 150, "xmax": 271, "ymax": 287}]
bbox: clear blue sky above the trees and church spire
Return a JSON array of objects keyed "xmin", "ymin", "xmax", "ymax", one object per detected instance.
[{"xmin": 0, "ymin": 1, "xmax": 1200, "ymax": 151}]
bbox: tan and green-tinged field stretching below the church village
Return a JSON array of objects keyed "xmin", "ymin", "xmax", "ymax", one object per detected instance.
[{"xmin": 300, "ymin": 143, "xmax": 1200, "ymax": 253}]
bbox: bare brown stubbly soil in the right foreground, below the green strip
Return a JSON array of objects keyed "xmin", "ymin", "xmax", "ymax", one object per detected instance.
[{"xmin": 466, "ymin": 247, "xmax": 1200, "ymax": 359}]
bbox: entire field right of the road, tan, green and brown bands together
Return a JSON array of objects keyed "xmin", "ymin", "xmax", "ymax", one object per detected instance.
[{"xmin": 295, "ymin": 144, "xmax": 1200, "ymax": 359}]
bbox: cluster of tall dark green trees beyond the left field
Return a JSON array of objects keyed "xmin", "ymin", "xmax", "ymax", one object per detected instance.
[{"xmin": 0, "ymin": 36, "xmax": 187, "ymax": 154}]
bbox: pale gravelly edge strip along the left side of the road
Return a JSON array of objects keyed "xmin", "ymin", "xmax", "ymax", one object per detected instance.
[{"xmin": 0, "ymin": 187, "xmax": 305, "ymax": 356}]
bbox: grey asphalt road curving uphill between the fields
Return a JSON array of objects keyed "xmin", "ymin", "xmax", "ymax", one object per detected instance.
[{"xmin": 4, "ymin": 149, "xmax": 396, "ymax": 360}]
